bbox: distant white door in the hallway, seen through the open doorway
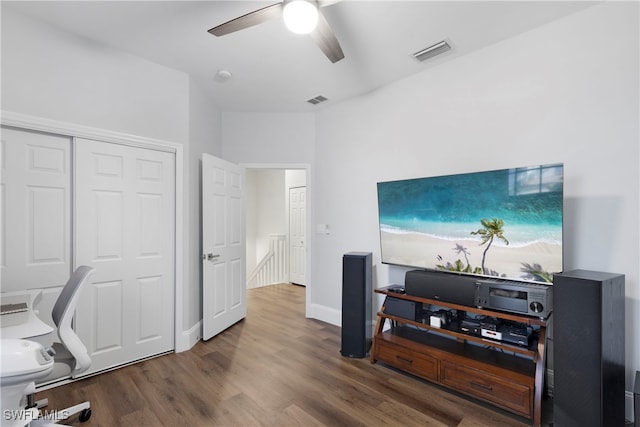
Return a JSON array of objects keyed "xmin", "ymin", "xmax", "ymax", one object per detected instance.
[{"xmin": 289, "ymin": 187, "xmax": 307, "ymax": 285}]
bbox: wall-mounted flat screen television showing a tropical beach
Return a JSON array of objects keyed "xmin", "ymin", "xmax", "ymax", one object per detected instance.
[{"xmin": 378, "ymin": 164, "xmax": 564, "ymax": 283}]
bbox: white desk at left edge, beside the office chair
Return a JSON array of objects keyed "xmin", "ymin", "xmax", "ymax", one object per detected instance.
[{"xmin": 0, "ymin": 291, "xmax": 53, "ymax": 348}]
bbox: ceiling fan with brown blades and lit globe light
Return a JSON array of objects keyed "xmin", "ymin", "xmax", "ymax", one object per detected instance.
[{"xmin": 209, "ymin": 0, "xmax": 344, "ymax": 63}]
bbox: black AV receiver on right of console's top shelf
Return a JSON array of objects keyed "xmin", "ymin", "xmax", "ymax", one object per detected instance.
[{"xmin": 475, "ymin": 280, "xmax": 553, "ymax": 319}]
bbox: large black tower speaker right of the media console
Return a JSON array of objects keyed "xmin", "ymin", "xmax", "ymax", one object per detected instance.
[{"xmin": 553, "ymin": 270, "xmax": 625, "ymax": 427}]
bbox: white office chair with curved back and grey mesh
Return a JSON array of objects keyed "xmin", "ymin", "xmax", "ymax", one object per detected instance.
[{"xmin": 31, "ymin": 265, "xmax": 95, "ymax": 426}]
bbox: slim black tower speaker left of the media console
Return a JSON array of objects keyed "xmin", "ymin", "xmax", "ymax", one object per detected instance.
[{"xmin": 340, "ymin": 252, "xmax": 373, "ymax": 357}]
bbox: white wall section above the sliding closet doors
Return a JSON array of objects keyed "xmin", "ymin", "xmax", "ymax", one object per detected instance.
[{"xmin": 2, "ymin": 7, "xmax": 189, "ymax": 143}]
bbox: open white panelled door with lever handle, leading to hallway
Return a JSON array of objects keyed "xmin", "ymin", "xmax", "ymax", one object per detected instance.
[{"xmin": 202, "ymin": 154, "xmax": 247, "ymax": 340}]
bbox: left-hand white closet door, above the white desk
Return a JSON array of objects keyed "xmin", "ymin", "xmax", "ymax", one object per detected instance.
[{"xmin": 0, "ymin": 127, "xmax": 71, "ymax": 292}]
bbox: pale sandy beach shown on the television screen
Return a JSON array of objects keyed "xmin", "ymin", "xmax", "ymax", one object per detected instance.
[{"xmin": 380, "ymin": 231, "xmax": 562, "ymax": 278}]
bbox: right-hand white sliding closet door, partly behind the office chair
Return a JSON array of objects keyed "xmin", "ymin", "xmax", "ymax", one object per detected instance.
[{"xmin": 75, "ymin": 139, "xmax": 175, "ymax": 375}]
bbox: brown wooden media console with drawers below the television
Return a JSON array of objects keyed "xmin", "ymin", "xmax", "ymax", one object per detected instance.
[{"xmin": 371, "ymin": 287, "xmax": 547, "ymax": 427}]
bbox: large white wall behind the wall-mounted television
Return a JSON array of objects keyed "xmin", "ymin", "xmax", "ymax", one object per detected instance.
[{"xmin": 312, "ymin": 2, "xmax": 640, "ymax": 404}]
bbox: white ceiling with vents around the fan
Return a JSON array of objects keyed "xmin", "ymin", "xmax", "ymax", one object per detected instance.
[{"xmin": 2, "ymin": 0, "xmax": 594, "ymax": 112}]
